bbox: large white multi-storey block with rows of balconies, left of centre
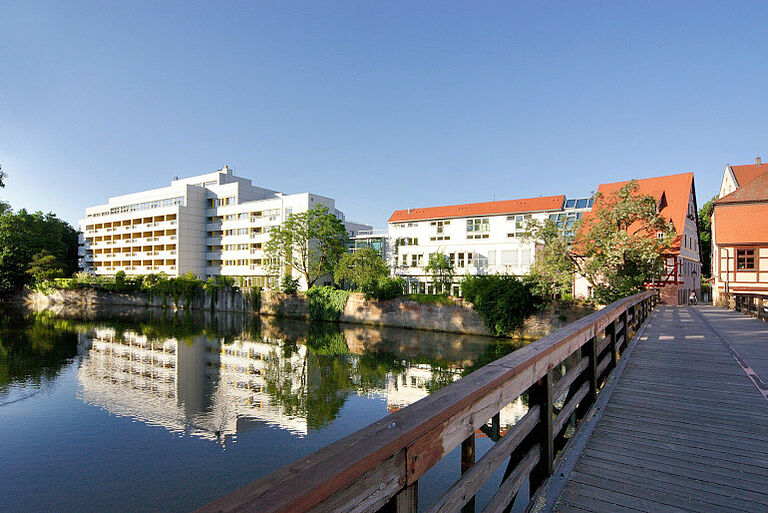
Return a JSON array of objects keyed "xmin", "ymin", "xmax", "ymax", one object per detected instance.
[{"xmin": 80, "ymin": 166, "xmax": 371, "ymax": 287}]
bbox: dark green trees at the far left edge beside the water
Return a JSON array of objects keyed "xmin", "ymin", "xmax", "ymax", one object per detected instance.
[{"xmin": 0, "ymin": 209, "xmax": 78, "ymax": 294}]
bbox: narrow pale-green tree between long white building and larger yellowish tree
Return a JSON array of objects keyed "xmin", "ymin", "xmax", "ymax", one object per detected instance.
[{"xmin": 523, "ymin": 219, "xmax": 579, "ymax": 297}]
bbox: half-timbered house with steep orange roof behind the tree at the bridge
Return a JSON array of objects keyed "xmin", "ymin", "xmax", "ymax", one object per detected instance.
[{"xmin": 574, "ymin": 173, "xmax": 701, "ymax": 305}]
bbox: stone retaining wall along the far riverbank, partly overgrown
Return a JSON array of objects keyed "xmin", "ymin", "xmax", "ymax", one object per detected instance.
[{"xmin": 21, "ymin": 289, "xmax": 595, "ymax": 340}]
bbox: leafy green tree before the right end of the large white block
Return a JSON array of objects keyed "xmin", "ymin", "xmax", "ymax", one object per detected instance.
[{"xmin": 264, "ymin": 205, "xmax": 347, "ymax": 287}]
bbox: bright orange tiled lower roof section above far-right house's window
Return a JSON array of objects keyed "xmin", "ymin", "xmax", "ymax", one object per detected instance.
[{"xmin": 714, "ymin": 203, "xmax": 768, "ymax": 245}]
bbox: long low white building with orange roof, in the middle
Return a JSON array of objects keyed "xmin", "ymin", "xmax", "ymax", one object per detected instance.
[{"xmin": 389, "ymin": 196, "xmax": 592, "ymax": 295}]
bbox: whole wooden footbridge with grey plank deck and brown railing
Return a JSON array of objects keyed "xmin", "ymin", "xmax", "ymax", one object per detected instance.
[{"xmin": 198, "ymin": 292, "xmax": 768, "ymax": 513}]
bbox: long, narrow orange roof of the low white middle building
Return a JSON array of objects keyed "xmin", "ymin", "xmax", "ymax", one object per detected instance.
[{"xmin": 389, "ymin": 195, "xmax": 565, "ymax": 223}]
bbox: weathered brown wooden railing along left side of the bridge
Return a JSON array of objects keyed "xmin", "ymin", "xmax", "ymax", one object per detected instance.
[{"xmin": 197, "ymin": 291, "xmax": 656, "ymax": 513}]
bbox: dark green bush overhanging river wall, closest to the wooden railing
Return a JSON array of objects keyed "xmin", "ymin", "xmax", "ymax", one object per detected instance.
[{"xmin": 461, "ymin": 275, "xmax": 545, "ymax": 336}]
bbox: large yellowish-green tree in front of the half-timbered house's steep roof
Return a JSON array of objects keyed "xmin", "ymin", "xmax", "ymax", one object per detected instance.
[{"xmin": 574, "ymin": 181, "xmax": 675, "ymax": 304}]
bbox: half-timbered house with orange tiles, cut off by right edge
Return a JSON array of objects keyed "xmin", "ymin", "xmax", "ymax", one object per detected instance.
[{"xmin": 712, "ymin": 159, "xmax": 768, "ymax": 304}]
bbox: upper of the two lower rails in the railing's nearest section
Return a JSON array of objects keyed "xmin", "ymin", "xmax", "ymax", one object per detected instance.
[{"xmin": 426, "ymin": 405, "xmax": 541, "ymax": 513}]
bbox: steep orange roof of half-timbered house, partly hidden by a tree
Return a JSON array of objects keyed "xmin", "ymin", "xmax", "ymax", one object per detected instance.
[{"xmin": 582, "ymin": 173, "xmax": 693, "ymax": 250}]
